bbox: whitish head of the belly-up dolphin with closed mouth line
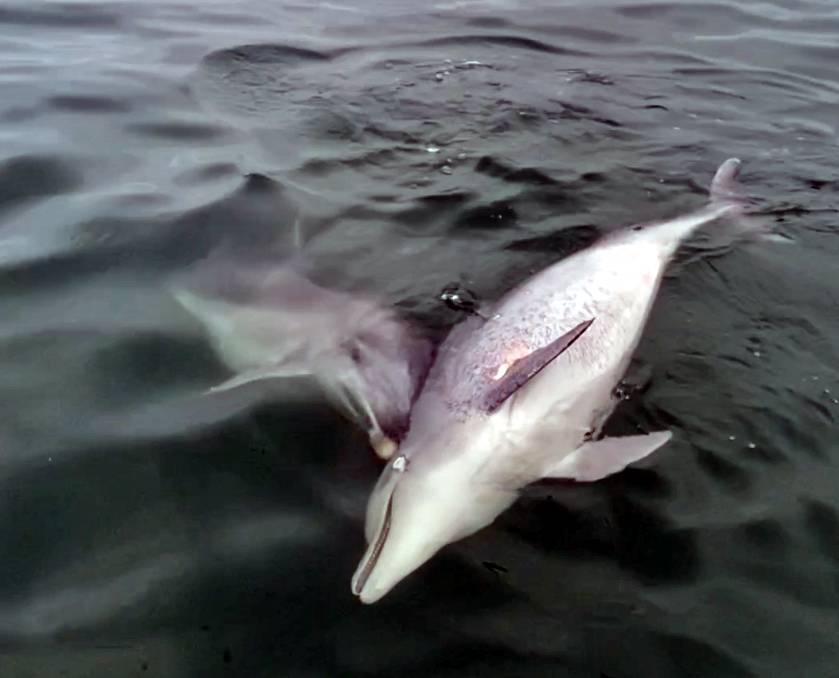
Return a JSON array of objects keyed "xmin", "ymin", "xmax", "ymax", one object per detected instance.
[{"xmin": 352, "ymin": 430, "xmax": 516, "ymax": 603}]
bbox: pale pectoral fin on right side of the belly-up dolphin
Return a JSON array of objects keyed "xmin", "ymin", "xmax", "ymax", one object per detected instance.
[{"xmin": 543, "ymin": 431, "xmax": 673, "ymax": 482}]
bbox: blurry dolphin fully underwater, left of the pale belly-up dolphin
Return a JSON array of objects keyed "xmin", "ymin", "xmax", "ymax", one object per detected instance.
[{"xmin": 173, "ymin": 256, "xmax": 430, "ymax": 458}]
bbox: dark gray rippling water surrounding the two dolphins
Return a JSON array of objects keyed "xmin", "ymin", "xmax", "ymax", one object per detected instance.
[{"xmin": 0, "ymin": 0, "xmax": 839, "ymax": 678}]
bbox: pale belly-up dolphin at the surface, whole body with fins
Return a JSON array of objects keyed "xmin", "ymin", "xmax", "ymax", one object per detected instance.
[{"xmin": 352, "ymin": 158, "xmax": 772, "ymax": 603}]
